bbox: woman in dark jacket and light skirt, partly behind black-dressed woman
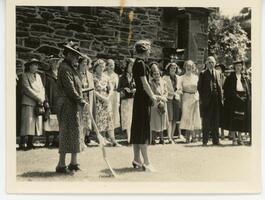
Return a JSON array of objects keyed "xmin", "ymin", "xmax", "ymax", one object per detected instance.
[{"xmin": 117, "ymin": 58, "xmax": 136, "ymax": 143}]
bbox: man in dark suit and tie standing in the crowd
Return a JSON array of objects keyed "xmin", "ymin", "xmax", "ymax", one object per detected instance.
[{"xmin": 198, "ymin": 56, "xmax": 223, "ymax": 146}]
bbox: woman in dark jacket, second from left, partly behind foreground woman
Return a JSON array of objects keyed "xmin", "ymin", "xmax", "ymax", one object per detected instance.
[{"xmin": 44, "ymin": 56, "xmax": 61, "ymax": 147}]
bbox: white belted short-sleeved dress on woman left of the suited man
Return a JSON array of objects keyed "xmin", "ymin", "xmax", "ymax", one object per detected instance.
[{"xmin": 178, "ymin": 74, "xmax": 201, "ymax": 130}]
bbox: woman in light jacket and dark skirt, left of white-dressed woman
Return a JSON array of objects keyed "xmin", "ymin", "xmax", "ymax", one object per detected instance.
[{"xmin": 163, "ymin": 63, "xmax": 181, "ymax": 143}]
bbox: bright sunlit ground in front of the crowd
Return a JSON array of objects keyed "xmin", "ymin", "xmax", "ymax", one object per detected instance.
[{"xmin": 17, "ymin": 137, "xmax": 253, "ymax": 181}]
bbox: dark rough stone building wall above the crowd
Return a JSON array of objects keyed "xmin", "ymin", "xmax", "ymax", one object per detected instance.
[{"xmin": 16, "ymin": 6, "xmax": 176, "ymax": 70}]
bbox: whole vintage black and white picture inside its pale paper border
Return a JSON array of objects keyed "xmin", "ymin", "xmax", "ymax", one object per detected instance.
[{"xmin": 5, "ymin": 0, "xmax": 260, "ymax": 192}]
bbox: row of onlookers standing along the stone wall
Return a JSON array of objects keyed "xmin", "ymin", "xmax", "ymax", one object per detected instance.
[{"xmin": 17, "ymin": 41, "xmax": 252, "ymax": 149}]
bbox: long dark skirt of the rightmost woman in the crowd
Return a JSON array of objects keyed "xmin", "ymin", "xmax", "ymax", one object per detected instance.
[{"xmin": 229, "ymin": 91, "xmax": 251, "ymax": 132}]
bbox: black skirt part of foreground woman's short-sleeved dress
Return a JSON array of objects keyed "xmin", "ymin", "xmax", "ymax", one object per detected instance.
[{"xmin": 130, "ymin": 92, "xmax": 150, "ymax": 144}]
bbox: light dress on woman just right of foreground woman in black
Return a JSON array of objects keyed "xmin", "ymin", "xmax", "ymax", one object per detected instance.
[{"xmin": 150, "ymin": 78, "xmax": 169, "ymax": 132}]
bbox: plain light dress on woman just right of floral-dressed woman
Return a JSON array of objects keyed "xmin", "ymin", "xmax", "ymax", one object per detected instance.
[{"xmin": 104, "ymin": 72, "xmax": 120, "ymax": 128}]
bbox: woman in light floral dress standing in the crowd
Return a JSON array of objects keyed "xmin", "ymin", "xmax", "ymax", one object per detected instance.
[{"xmin": 94, "ymin": 59, "xmax": 121, "ymax": 146}]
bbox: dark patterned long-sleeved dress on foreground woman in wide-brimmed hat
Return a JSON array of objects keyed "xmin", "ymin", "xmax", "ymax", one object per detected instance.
[{"xmin": 57, "ymin": 60, "xmax": 85, "ymax": 153}]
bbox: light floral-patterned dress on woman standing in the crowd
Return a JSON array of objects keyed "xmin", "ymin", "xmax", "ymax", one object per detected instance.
[{"xmin": 94, "ymin": 74, "xmax": 114, "ymax": 132}]
